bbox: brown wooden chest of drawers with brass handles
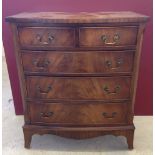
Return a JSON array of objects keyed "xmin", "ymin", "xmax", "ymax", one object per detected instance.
[{"xmin": 6, "ymin": 12, "xmax": 148, "ymax": 149}]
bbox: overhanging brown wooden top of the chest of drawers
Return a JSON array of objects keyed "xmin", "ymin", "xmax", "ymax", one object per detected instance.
[{"xmin": 6, "ymin": 11, "xmax": 148, "ymax": 23}]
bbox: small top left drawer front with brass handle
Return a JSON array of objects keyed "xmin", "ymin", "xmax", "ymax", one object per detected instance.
[{"xmin": 18, "ymin": 27, "xmax": 75, "ymax": 49}]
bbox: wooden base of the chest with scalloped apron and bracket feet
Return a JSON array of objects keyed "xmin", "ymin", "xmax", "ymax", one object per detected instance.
[{"xmin": 23, "ymin": 125, "xmax": 135, "ymax": 149}]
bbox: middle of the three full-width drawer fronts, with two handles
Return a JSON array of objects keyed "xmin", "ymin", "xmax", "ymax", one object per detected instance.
[{"xmin": 27, "ymin": 77, "xmax": 131, "ymax": 100}]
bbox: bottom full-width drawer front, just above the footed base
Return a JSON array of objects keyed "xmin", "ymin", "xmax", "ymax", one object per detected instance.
[{"xmin": 30, "ymin": 103, "xmax": 127, "ymax": 125}]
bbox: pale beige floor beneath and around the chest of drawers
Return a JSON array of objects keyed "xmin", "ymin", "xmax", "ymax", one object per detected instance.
[{"xmin": 2, "ymin": 57, "xmax": 153, "ymax": 155}]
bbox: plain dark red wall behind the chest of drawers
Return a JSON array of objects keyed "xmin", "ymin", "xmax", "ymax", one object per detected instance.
[{"xmin": 2, "ymin": 0, "xmax": 153, "ymax": 115}]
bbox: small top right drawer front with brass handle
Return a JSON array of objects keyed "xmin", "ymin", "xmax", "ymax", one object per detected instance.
[{"xmin": 79, "ymin": 27, "xmax": 138, "ymax": 47}]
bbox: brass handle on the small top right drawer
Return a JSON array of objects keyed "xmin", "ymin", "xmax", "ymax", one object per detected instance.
[{"xmin": 101, "ymin": 33, "xmax": 120, "ymax": 45}]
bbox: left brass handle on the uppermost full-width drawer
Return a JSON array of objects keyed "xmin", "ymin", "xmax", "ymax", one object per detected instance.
[{"xmin": 32, "ymin": 59, "xmax": 50, "ymax": 70}]
